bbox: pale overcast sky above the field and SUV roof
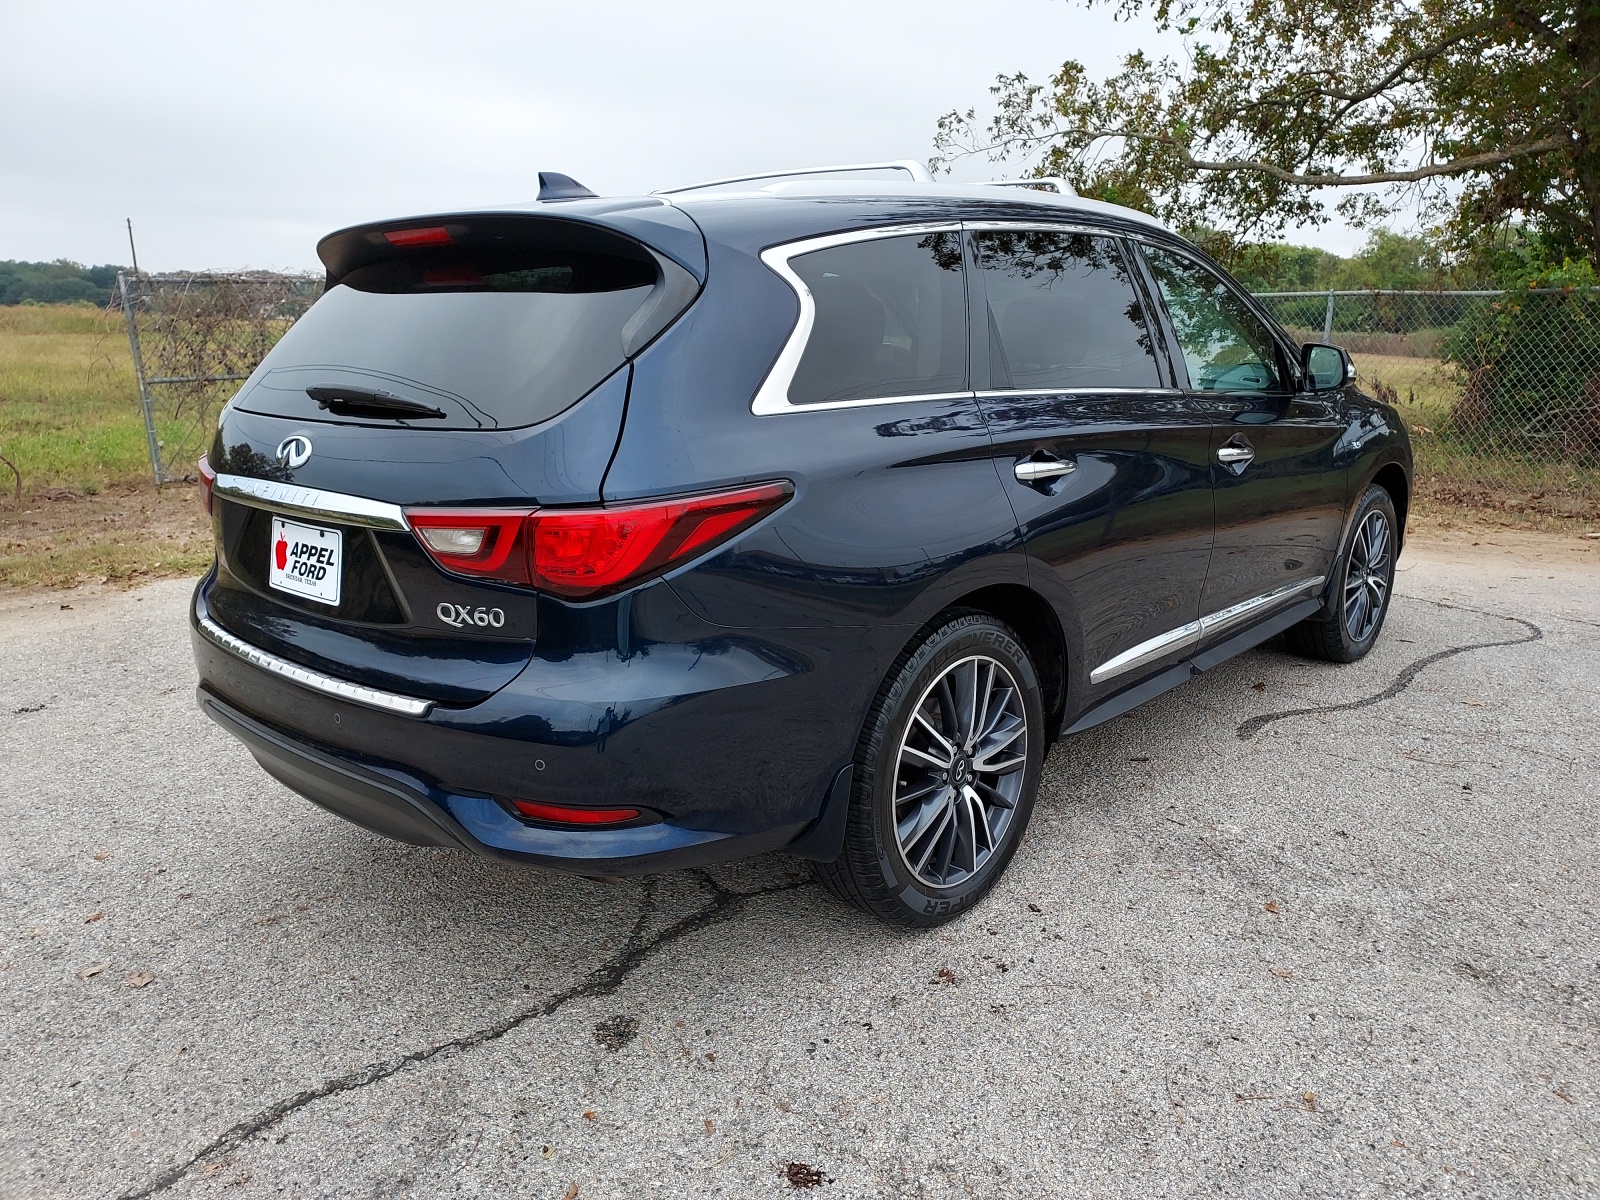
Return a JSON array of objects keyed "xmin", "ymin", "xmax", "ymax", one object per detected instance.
[{"xmin": 0, "ymin": 0, "xmax": 1358, "ymax": 270}]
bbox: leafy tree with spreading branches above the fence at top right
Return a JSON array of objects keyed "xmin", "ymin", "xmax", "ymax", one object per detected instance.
[{"xmin": 936, "ymin": 0, "xmax": 1600, "ymax": 259}]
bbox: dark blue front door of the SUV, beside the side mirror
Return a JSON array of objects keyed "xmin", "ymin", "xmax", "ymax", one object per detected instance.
[{"xmin": 1142, "ymin": 245, "xmax": 1346, "ymax": 621}]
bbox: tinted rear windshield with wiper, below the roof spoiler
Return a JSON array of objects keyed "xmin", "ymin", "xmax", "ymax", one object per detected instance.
[{"xmin": 237, "ymin": 246, "xmax": 659, "ymax": 429}]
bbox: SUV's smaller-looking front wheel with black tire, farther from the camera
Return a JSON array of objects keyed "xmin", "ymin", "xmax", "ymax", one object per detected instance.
[{"xmin": 1285, "ymin": 483, "xmax": 1400, "ymax": 662}]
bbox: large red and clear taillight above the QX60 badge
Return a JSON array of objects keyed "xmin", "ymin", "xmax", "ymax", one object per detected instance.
[{"xmin": 406, "ymin": 483, "xmax": 794, "ymax": 600}]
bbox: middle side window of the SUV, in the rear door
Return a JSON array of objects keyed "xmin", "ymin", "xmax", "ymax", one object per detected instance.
[{"xmin": 978, "ymin": 230, "xmax": 1162, "ymax": 392}]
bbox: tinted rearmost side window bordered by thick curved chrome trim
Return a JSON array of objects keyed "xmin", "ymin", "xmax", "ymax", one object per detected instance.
[{"xmin": 789, "ymin": 234, "xmax": 966, "ymax": 405}]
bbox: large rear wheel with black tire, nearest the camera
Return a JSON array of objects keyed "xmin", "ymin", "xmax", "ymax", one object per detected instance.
[{"xmin": 816, "ymin": 613, "xmax": 1045, "ymax": 930}]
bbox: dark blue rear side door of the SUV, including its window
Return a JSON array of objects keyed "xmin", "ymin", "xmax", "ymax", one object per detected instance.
[{"xmin": 974, "ymin": 227, "xmax": 1213, "ymax": 699}]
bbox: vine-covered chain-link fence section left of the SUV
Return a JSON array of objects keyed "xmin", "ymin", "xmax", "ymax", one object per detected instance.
[{"xmin": 117, "ymin": 270, "xmax": 323, "ymax": 483}]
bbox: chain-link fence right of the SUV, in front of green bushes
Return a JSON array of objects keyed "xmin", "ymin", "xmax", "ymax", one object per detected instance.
[{"xmin": 1259, "ymin": 290, "xmax": 1600, "ymax": 520}]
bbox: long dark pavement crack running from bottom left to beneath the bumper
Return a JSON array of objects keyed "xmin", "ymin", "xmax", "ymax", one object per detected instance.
[{"xmin": 120, "ymin": 870, "xmax": 810, "ymax": 1200}]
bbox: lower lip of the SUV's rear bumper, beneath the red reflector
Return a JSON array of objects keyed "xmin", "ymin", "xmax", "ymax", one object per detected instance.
[{"xmin": 197, "ymin": 685, "xmax": 806, "ymax": 875}]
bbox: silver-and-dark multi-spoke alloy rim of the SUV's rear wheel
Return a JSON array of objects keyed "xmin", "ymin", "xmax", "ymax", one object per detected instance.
[{"xmin": 894, "ymin": 654, "xmax": 1027, "ymax": 888}]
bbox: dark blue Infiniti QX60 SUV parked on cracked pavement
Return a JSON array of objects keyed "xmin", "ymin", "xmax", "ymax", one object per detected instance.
[{"xmin": 192, "ymin": 164, "xmax": 1411, "ymax": 926}]
